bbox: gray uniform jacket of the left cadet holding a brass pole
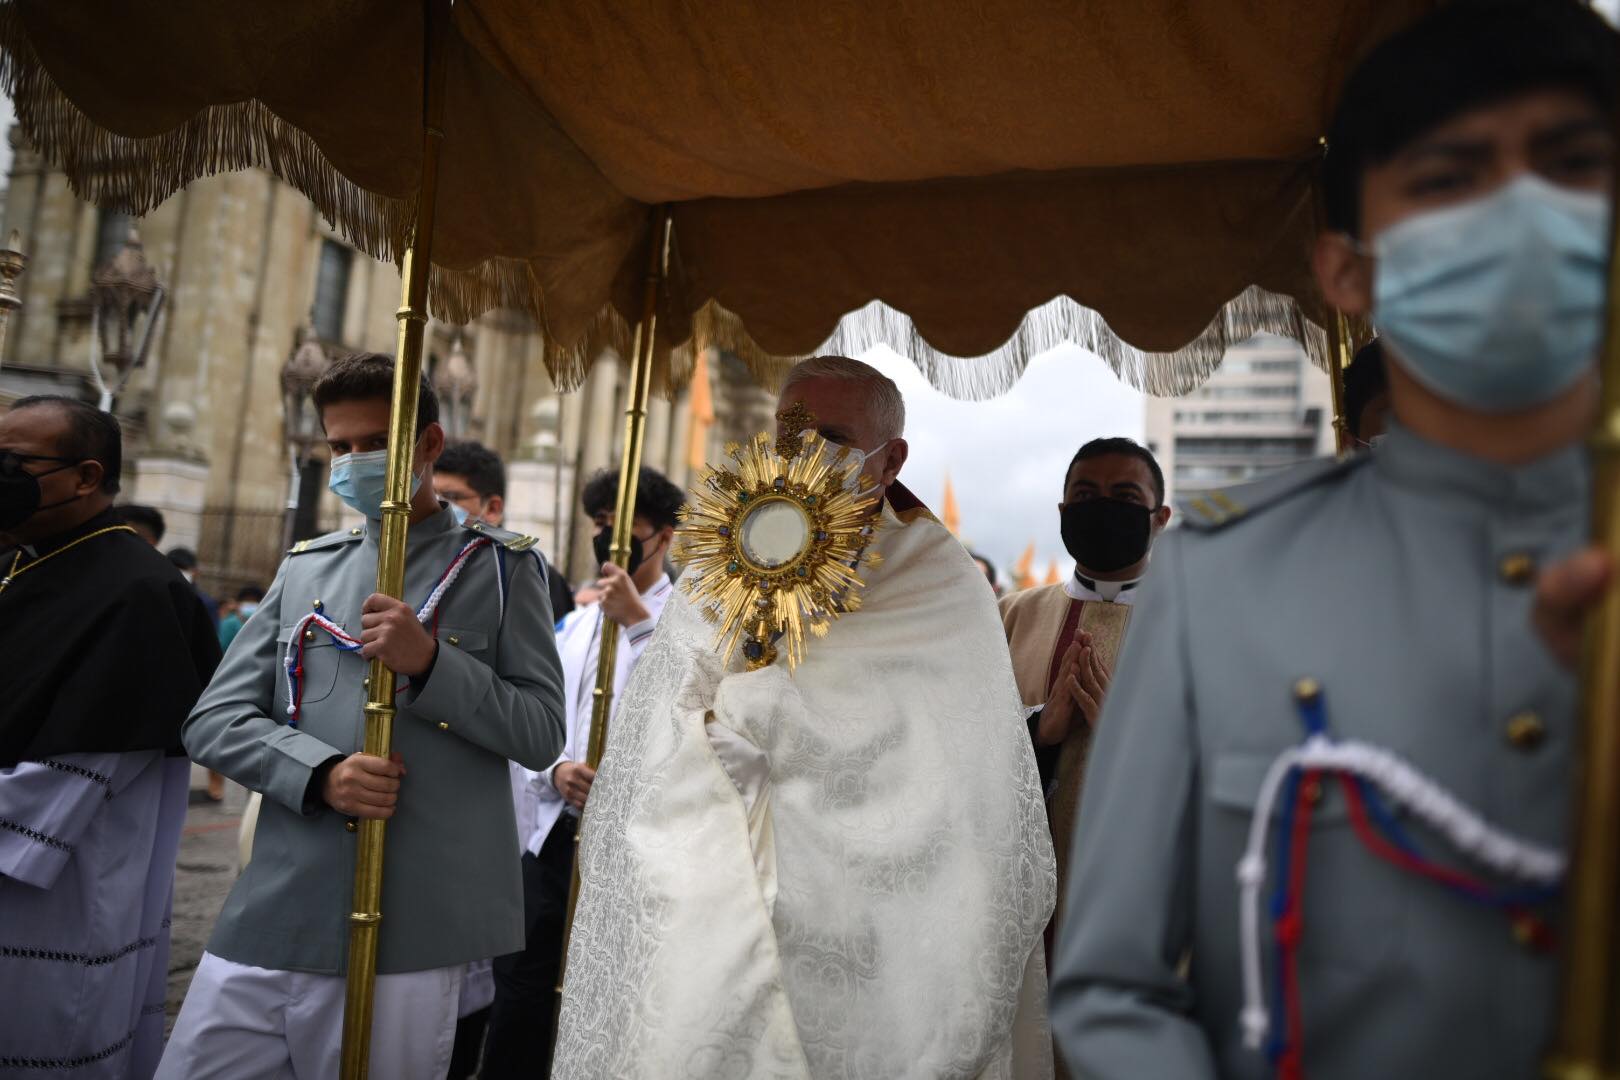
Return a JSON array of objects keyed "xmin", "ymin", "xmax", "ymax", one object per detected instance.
[{"xmin": 185, "ymin": 510, "xmax": 562, "ymax": 973}]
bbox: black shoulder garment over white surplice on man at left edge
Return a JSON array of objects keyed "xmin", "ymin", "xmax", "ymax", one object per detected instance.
[{"xmin": 0, "ymin": 510, "xmax": 220, "ymax": 767}]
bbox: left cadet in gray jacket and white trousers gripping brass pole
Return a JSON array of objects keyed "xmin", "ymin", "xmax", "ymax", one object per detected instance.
[{"xmin": 159, "ymin": 353, "xmax": 562, "ymax": 1078}]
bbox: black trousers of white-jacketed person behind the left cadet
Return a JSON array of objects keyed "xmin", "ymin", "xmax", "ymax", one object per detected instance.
[{"xmin": 478, "ymin": 813, "xmax": 578, "ymax": 1080}]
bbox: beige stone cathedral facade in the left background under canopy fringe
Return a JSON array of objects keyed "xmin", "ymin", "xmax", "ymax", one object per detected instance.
[{"xmin": 0, "ymin": 130, "xmax": 774, "ymax": 594}]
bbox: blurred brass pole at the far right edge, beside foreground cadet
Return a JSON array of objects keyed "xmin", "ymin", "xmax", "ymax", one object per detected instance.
[{"xmin": 1545, "ymin": 177, "xmax": 1620, "ymax": 1080}]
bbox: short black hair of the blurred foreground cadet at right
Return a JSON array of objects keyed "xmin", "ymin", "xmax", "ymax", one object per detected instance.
[{"xmin": 1322, "ymin": 0, "xmax": 1620, "ymax": 235}]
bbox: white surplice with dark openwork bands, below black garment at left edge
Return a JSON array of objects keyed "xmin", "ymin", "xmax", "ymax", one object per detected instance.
[{"xmin": 0, "ymin": 750, "xmax": 191, "ymax": 1080}]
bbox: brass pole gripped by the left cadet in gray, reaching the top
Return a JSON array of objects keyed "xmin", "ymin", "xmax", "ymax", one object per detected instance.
[{"xmin": 342, "ymin": 0, "xmax": 450, "ymax": 1080}]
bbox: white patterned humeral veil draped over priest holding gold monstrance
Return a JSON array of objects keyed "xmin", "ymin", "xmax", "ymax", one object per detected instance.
[{"xmin": 552, "ymin": 507, "xmax": 1056, "ymax": 1080}]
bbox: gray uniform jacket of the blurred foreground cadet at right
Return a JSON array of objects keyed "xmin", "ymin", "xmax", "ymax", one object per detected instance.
[{"xmin": 1051, "ymin": 431, "xmax": 1588, "ymax": 1080}]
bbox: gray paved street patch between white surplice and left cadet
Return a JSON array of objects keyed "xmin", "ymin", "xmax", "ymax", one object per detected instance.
[{"xmin": 168, "ymin": 766, "xmax": 248, "ymax": 1027}]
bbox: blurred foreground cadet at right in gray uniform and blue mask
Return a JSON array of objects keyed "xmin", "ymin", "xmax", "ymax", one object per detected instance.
[{"xmin": 1051, "ymin": 0, "xmax": 1617, "ymax": 1080}]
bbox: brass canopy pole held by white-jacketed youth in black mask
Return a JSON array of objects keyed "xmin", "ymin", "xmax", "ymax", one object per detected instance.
[{"xmin": 557, "ymin": 206, "xmax": 671, "ymax": 994}]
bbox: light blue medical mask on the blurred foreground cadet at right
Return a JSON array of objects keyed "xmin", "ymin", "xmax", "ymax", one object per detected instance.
[{"xmin": 1371, "ymin": 173, "xmax": 1609, "ymax": 413}]
